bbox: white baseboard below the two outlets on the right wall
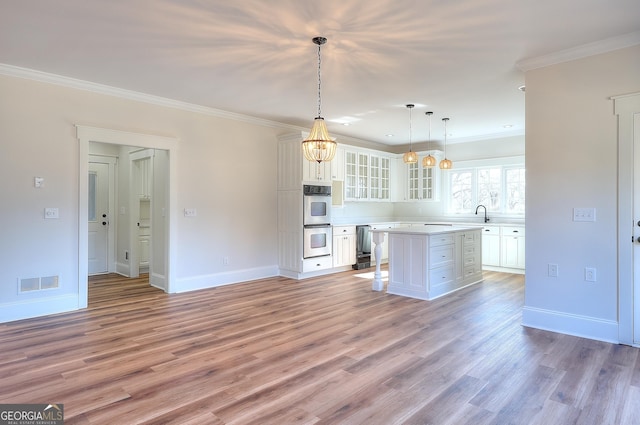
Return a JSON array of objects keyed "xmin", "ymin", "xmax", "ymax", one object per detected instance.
[{"xmin": 522, "ymin": 307, "xmax": 619, "ymax": 344}]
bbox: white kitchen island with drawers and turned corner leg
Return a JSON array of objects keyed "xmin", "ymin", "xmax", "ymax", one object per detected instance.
[{"xmin": 371, "ymin": 225, "xmax": 482, "ymax": 300}]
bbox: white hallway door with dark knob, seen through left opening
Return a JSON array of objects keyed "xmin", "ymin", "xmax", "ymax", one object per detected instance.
[{"xmin": 87, "ymin": 162, "xmax": 110, "ymax": 275}]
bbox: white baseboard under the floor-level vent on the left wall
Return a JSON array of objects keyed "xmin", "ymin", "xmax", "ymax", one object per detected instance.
[{"xmin": 0, "ymin": 294, "xmax": 79, "ymax": 323}]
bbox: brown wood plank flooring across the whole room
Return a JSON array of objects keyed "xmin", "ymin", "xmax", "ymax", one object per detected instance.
[{"xmin": 0, "ymin": 271, "xmax": 640, "ymax": 425}]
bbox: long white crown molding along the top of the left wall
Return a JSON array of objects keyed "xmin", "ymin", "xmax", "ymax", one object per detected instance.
[{"xmin": 0, "ymin": 63, "xmax": 300, "ymax": 130}]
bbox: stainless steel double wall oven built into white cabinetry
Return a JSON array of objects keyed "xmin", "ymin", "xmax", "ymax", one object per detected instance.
[{"xmin": 302, "ymin": 185, "xmax": 333, "ymax": 258}]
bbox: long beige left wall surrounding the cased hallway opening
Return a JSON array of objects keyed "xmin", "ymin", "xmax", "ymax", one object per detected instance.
[{"xmin": 0, "ymin": 76, "xmax": 282, "ymax": 321}]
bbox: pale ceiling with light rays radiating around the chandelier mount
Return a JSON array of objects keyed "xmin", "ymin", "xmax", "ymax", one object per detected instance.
[{"xmin": 0, "ymin": 0, "xmax": 640, "ymax": 147}]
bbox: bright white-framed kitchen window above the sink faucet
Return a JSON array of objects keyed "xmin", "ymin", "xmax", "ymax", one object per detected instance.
[{"xmin": 447, "ymin": 165, "xmax": 525, "ymax": 215}]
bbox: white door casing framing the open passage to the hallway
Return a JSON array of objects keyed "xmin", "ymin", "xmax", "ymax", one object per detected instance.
[{"xmin": 76, "ymin": 125, "xmax": 177, "ymax": 308}]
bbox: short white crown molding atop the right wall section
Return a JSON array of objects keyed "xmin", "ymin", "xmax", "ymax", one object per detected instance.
[{"xmin": 516, "ymin": 31, "xmax": 640, "ymax": 72}]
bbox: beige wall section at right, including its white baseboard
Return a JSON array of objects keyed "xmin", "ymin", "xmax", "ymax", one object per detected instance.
[{"xmin": 523, "ymin": 46, "xmax": 640, "ymax": 341}]
